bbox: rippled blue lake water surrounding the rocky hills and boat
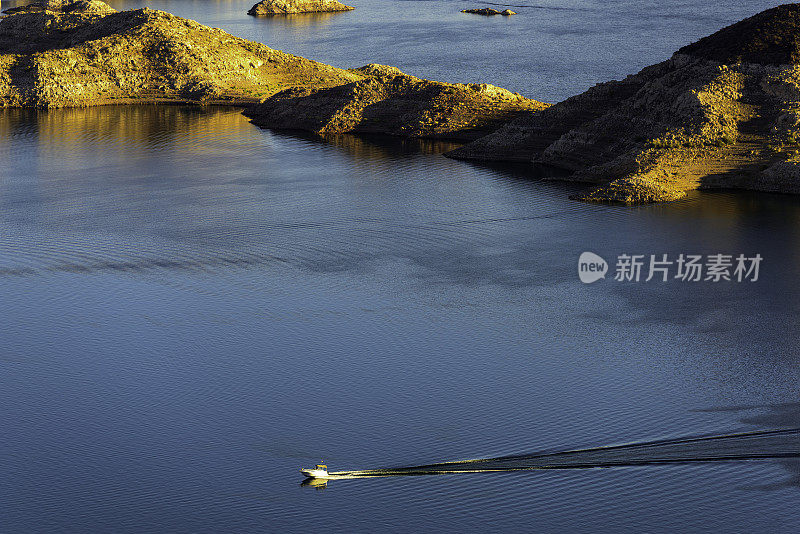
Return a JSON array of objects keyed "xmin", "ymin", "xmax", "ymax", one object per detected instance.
[{"xmin": 0, "ymin": 0, "xmax": 800, "ymax": 533}]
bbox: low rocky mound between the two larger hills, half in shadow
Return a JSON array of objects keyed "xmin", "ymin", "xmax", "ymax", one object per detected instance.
[{"xmin": 245, "ymin": 65, "xmax": 547, "ymax": 140}]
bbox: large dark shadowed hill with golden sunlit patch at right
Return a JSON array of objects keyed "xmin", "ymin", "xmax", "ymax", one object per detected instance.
[{"xmin": 448, "ymin": 4, "xmax": 800, "ymax": 204}]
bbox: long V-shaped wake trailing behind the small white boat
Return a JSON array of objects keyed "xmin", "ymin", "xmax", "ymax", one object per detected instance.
[{"xmin": 330, "ymin": 428, "xmax": 800, "ymax": 479}]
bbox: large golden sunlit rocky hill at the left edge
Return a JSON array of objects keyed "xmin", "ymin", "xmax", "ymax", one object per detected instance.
[{"xmin": 0, "ymin": 0, "xmax": 363, "ymax": 107}]
